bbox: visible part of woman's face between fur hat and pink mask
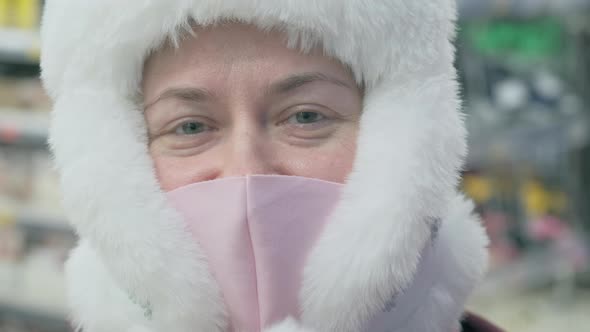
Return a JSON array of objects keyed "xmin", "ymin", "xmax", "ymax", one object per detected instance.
[{"xmin": 142, "ymin": 25, "xmax": 362, "ymax": 191}]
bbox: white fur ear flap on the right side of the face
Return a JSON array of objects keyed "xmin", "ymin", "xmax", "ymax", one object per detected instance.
[{"xmin": 301, "ymin": 77, "xmax": 464, "ymax": 331}]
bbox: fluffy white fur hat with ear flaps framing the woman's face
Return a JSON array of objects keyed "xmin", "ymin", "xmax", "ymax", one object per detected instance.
[{"xmin": 41, "ymin": 0, "xmax": 486, "ymax": 332}]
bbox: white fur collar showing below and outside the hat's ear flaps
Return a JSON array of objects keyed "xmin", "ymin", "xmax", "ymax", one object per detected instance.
[{"xmin": 66, "ymin": 195, "xmax": 487, "ymax": 332}]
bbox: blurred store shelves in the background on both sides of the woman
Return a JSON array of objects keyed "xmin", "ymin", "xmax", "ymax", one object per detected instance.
[{"xmin": 0, "ymin": 0, "xmax": 590, "ymax": 332}]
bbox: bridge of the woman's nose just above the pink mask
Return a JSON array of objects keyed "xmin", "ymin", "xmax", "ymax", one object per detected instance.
[{"xmin": 223, "ymin": 116, "xmax": 273, "ymax": 177}]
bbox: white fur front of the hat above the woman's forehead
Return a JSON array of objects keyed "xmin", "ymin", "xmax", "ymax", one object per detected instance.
[{"xmin": 41, "ymin": 0, "xmax": 456, "ymax": 97}]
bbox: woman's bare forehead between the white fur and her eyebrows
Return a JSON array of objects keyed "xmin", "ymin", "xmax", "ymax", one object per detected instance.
[{"xmin": 143, "ymin": 23, "xmax": 353, "ymax": 88}]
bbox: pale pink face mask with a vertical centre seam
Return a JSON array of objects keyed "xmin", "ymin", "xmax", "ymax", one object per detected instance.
[{"xmin": 168, "ymin": 175, "xmax": 342, "ymax": 331}]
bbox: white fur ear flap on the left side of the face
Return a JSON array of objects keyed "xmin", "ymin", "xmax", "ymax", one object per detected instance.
[{"xmin": 50, "ymin": 90, "xmax": 225, "ymax": 332}]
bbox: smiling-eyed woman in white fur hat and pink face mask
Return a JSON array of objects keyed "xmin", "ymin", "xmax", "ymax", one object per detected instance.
[{"xmin": 42, "ymin": 0, "xmax": 504, "ymax": 332}]
